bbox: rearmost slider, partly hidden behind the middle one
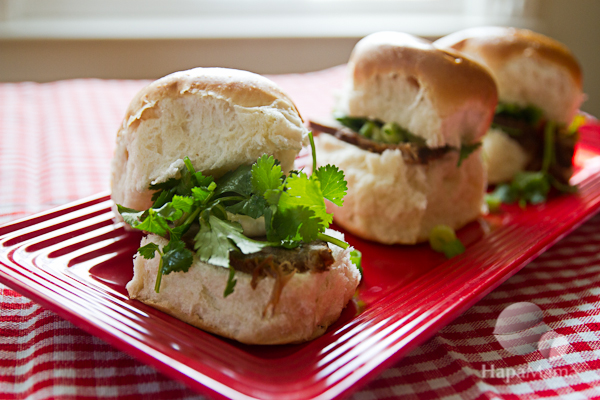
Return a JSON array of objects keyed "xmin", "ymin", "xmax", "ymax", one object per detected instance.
[{"xmin": 434, "ymin": 27, "xmax": 584, "ymax": 184}]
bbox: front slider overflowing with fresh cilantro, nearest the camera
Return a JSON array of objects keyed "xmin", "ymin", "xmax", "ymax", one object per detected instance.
[{"xmin": 112, "ymin": 68, "xmax": 360, "ymax": 344}]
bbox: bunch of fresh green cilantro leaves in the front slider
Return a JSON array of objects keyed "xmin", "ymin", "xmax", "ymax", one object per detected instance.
[{"xmin": 117, "ymin": 134, "xmax": 357, "ymax": 297}]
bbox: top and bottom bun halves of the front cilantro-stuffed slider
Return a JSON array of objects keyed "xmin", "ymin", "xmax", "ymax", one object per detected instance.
[{"xmin": 112, "ymin": 68, "xmax": 360, "ymax": 344}]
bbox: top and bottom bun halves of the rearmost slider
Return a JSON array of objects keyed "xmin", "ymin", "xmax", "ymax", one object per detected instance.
[{"xmin": 434, "ymin": 27, "xmax": 584, "ymax": 183}]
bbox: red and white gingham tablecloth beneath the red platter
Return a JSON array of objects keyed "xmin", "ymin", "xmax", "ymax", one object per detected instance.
[{"xmin": 0, "ymin": 68, "xmax": 600, "ymax": 400}]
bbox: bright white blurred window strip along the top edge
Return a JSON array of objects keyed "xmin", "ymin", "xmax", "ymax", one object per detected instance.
[{"xmin": 0, "ymin": 0, "xmax": 540, "ymax": 39}]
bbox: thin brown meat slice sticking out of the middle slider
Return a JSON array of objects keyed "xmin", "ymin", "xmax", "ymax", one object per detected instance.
[{"xmin": 310, "ymin": 121, "xmax": 452, "ymax": 164}]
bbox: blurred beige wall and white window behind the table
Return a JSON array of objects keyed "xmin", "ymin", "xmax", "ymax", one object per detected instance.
[{"xmin": 0, "ymin": 0, "xmax": 600, "ymax": 116}]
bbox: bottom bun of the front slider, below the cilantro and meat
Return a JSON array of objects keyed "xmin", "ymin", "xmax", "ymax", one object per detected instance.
[{"xmin": 127, "ymin": 231, "xmax": 360, "ymax": 344}]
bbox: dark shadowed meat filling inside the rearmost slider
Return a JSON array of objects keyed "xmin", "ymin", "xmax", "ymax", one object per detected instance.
[{"xmin": 493, "ymin": 114, "xmax": 578, "ymax": 184}]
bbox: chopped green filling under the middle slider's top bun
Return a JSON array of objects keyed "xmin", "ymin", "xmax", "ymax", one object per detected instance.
[{"xmin": 336, "ymin": 115, "xmax": 481, "ymax": 167}]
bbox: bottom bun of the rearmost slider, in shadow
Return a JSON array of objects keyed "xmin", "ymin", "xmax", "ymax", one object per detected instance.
[{"xmin": 482, "ymin": 129, "xmax": 530, "ymax": 184}]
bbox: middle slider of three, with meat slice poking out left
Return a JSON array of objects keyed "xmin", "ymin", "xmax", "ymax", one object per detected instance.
[{"xmin": 317, "ymin": 32, "xmax": 496, "ymax": 244}]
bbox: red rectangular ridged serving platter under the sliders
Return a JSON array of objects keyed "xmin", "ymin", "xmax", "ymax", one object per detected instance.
[{"xmin": 0, "ymin": 125, "xmax": 600, "ymax": 399}]
